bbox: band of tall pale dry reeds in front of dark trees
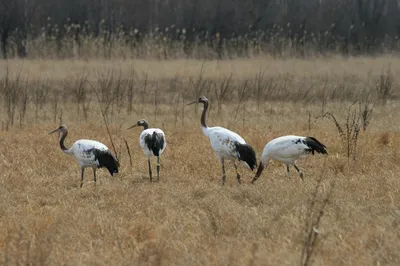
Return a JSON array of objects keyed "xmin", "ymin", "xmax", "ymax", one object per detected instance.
[{"xmin": 2, "ymin": 19, "xmax": 400, "ymax": 60}]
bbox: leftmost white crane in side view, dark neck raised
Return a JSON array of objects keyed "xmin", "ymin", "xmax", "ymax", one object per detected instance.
[{"xmin": 49, "ymin": 125, "xmax": 119, "ymax": 187}]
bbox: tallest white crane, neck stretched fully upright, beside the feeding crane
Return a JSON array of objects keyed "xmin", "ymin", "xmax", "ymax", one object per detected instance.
[{"xmin": 188, "ymin": 96, "xmax": 257, "ymax": 184}]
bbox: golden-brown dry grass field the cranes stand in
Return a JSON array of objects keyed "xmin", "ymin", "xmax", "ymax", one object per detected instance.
[{"xmin": 0, "ymin": 57, "xmax": 400, "ymax": 265}]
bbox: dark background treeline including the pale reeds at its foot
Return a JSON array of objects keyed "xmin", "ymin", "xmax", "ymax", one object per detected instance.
[{"xmin": 0, "ymin": 0, "xmax": 400, "ymax": 58}]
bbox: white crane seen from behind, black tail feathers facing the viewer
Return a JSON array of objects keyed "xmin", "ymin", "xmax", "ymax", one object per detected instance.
[{"xmin": 128, "ymin": 119, "xmax": 167, "ymax": 182}]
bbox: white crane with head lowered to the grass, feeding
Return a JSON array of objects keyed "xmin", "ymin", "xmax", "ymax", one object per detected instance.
[{"xmin": 251, "ymin": 135, "xmax": 328, "ymax": 184}]
